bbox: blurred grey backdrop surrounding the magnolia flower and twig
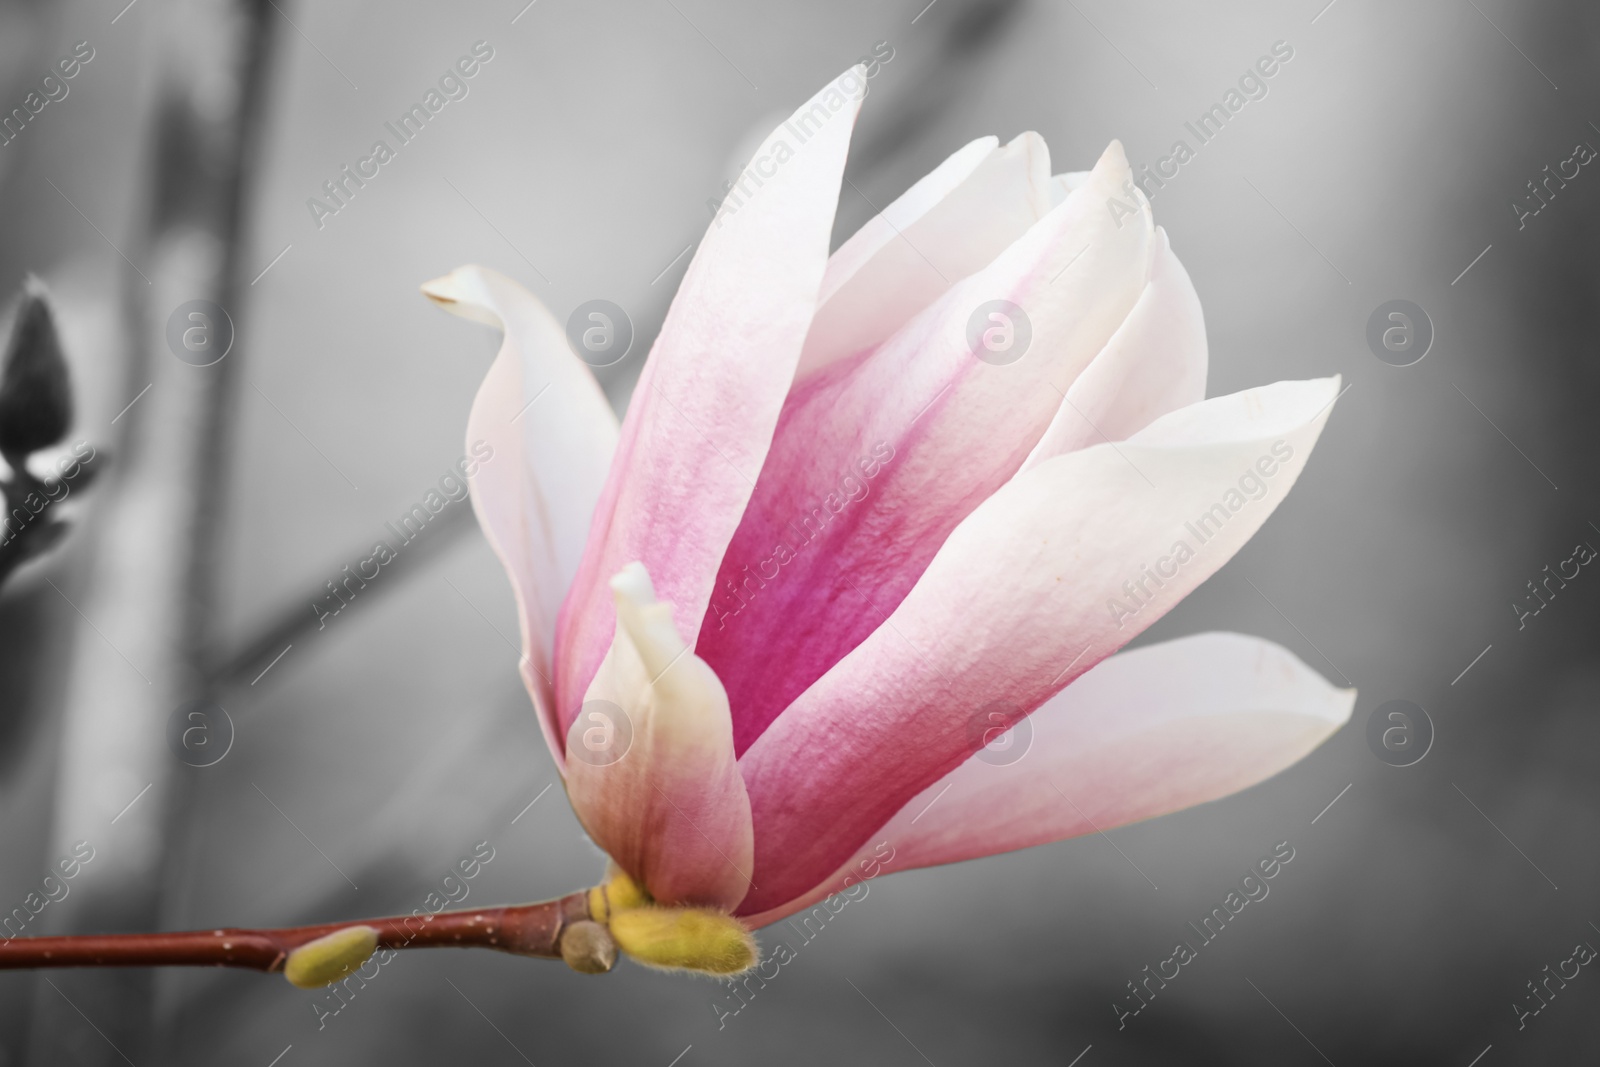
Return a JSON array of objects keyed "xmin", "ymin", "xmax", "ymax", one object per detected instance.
[{"xmin": 0, "ymin": 0, "xmax": 1600, "ymax": 1067}]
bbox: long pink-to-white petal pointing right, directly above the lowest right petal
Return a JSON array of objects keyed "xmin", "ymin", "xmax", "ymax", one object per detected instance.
[{"xmin": 739, "ymin": 379, "xmax": 1338, "ymax": 913}]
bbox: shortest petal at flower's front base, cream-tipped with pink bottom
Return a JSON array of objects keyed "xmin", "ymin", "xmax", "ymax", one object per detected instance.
[{"xmin": 566, "ymin": 563, "xmax": 752, "ymax": 909}]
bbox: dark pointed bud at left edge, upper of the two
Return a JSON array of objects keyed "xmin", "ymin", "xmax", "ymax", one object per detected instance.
[{"xmin": 0, "ymin": 275, "xmax": 72, "ymax": 466}]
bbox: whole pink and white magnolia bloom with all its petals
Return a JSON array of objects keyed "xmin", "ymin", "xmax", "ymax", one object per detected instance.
[{"xmin": 424, "ymin": 69, "xmax": 1355, "ymax": 966}]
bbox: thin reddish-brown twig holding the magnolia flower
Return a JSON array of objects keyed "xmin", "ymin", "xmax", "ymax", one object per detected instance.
[{"xmin": 0, "ymin": 891, "xmax": 590, "ymax": 971}]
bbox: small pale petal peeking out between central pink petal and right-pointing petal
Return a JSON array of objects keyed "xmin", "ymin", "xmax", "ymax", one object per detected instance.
[{"xmin": 1022, "ymin": 227, "xmax": 1206, "ymax": 470}]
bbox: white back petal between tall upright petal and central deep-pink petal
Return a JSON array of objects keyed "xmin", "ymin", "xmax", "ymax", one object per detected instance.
[{"xmin": 795, "ymin": 133, "xmax": 1051, "ymax": 384}]
